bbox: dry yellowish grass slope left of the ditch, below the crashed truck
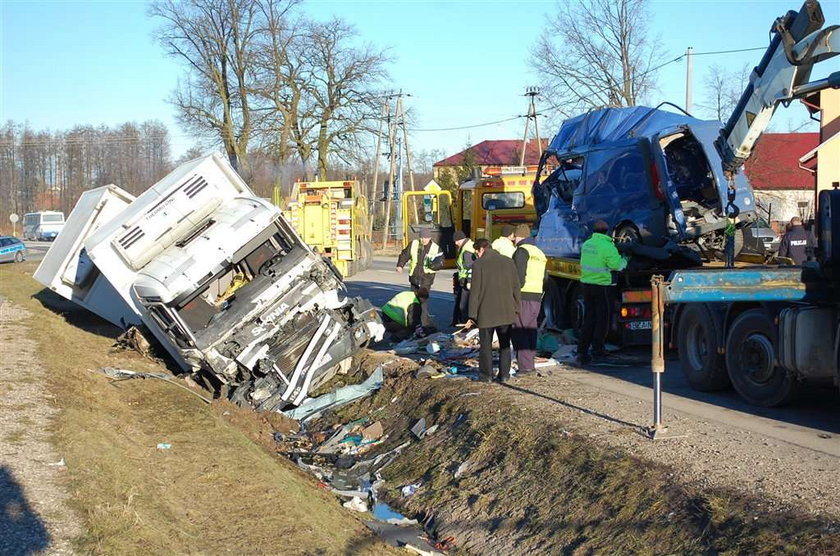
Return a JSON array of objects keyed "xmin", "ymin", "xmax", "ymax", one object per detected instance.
[{"xmin": 0, "ymin": 263, "xmax": 396, "ymax": 554}]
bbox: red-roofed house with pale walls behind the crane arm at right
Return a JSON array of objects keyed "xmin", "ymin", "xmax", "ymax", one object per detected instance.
[{"xmin": 744, "ymin": 133, "xmax": 820, "ymax": 227}]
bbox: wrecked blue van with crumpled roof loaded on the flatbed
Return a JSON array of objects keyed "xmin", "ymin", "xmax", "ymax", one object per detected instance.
[{"xmin": 533, "ymin": 106, "xmax": 757, "ymax": 258}]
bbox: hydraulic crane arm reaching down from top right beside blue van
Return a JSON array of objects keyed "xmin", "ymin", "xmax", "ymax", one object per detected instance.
[{"xmin": 715, "ymin": 0, "xmax": 840, "ymax": 175}]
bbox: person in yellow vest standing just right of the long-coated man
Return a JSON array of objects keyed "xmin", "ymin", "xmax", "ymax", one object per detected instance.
[{"xmin": 511, "ymin": 224, "xmax": 547, "ymax": 375}]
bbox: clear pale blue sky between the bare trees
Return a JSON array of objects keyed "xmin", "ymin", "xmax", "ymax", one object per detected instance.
[{"xmin": 0, "ymin": 0, "xmax": 840, "ymax": 161}]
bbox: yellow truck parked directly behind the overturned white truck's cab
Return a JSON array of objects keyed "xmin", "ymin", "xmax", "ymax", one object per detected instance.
[{"xmin": 272, "ymin": 181, "xmax": 373, "ymax": 277}]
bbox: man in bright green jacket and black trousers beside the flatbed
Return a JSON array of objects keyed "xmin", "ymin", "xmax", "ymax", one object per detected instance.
[{"xmin": 578, "ymin": 220, "xmax": 627, "ymax": 365}]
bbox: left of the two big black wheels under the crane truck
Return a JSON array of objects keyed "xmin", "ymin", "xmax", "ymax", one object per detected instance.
[{"xmin": 677, "ymin": 305, "xmax": 729, "ymax": 392}]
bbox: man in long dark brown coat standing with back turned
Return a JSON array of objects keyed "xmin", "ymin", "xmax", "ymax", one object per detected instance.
[{"xmin": 468, "ymin": 238, "xmax": 520, "ymax": 383}]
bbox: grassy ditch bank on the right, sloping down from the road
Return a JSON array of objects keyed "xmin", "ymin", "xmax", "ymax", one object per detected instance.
[{"xmin": 324, "ymin": 355, "xmax": 840, "ymax": 554}]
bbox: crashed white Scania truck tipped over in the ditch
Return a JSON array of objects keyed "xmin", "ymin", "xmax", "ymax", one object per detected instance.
[{"xmin": 35, "ymin": 154, "xmax": 383, "ymax": 411}]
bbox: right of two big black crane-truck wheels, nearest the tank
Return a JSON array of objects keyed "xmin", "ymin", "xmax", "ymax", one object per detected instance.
[{"xmin": 726, "ymin": 309, "xmax": 799, "ymax": 407}]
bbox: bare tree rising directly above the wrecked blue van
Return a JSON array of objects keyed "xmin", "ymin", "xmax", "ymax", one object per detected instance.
[{"xmin": 530, "ymin": 0, "xmax": 661, "ymax": 116}]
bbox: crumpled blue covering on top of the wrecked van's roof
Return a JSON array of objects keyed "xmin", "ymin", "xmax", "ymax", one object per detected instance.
[{"xmin": 548, "ymin": 106, "xmax": 721, "ymax": 154}]
